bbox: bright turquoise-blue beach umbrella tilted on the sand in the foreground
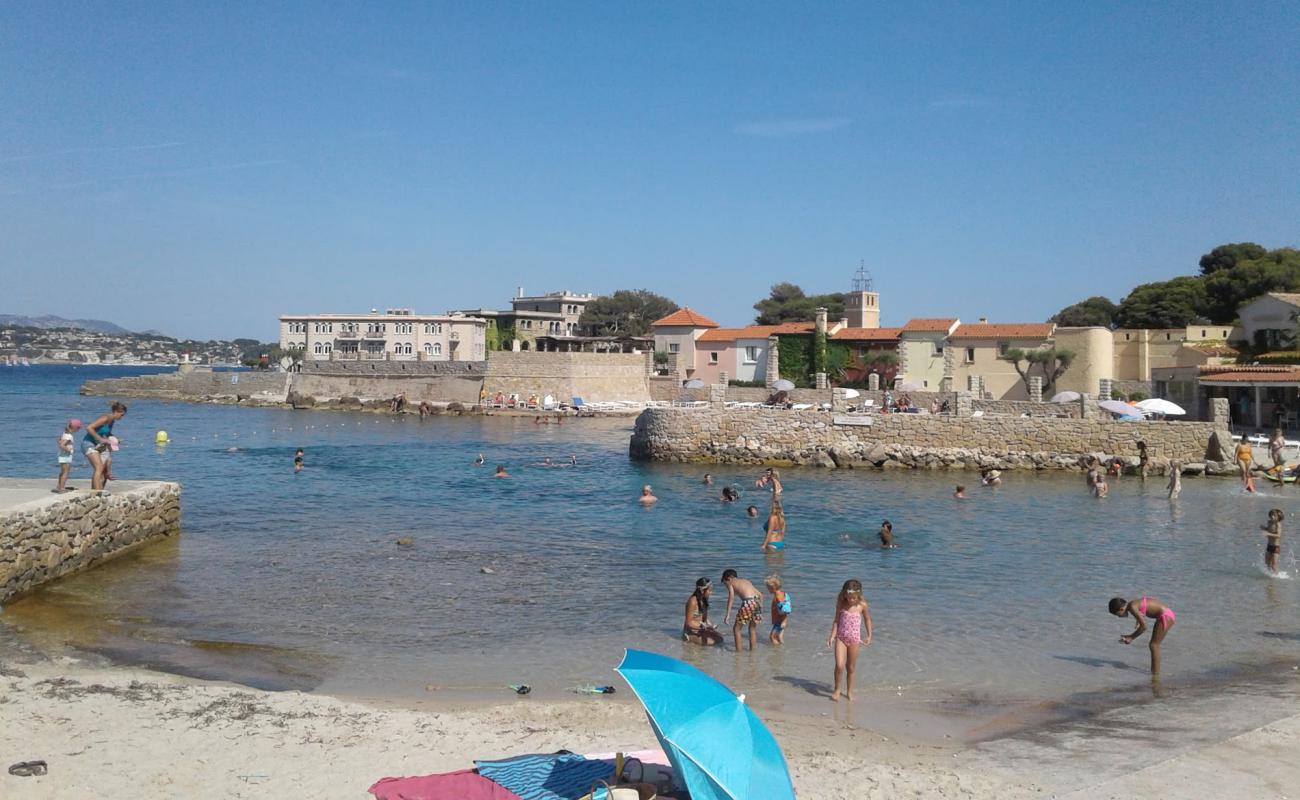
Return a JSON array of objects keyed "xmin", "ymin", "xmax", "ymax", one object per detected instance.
[{"xmin": 618, "ymin": 650, "xmax": 794, "ymax": 800}]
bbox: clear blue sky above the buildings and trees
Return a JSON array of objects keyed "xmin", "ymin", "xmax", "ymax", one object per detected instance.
[{"xmin": 0, "ymin": 3, "xmax": 1300, "ymax": 340}]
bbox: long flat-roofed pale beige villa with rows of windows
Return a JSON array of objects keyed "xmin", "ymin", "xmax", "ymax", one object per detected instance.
[{"xmin": 280, "ymin": 308, "xmax": 488, "ymax": 362}]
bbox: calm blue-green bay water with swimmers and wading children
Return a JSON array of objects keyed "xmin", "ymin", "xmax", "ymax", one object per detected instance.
[{"xmin": 0, "ymin": 367, "xmax": 1300, "ymax": 744}]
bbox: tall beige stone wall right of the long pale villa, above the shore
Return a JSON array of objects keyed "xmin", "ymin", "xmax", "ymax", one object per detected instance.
[{"xmin": 484, "ymin": 351, "xmax": 653, "ymax": 402}]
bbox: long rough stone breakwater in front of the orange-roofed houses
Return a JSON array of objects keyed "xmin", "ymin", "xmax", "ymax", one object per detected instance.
[{"xmin": 629, "ymin": 408, "xmax": 1230, "ymax": 473}]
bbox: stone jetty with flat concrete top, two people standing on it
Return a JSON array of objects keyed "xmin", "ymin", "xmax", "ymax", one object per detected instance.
[{"xmin": 0, "ymin": 479, "xmax": 181, "ymax": 604}]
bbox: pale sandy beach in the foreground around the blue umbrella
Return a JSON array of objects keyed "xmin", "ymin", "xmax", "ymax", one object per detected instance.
[{"xmin": 0, "ymin": 657, "xmax": 1300, "ymax": 800}]
